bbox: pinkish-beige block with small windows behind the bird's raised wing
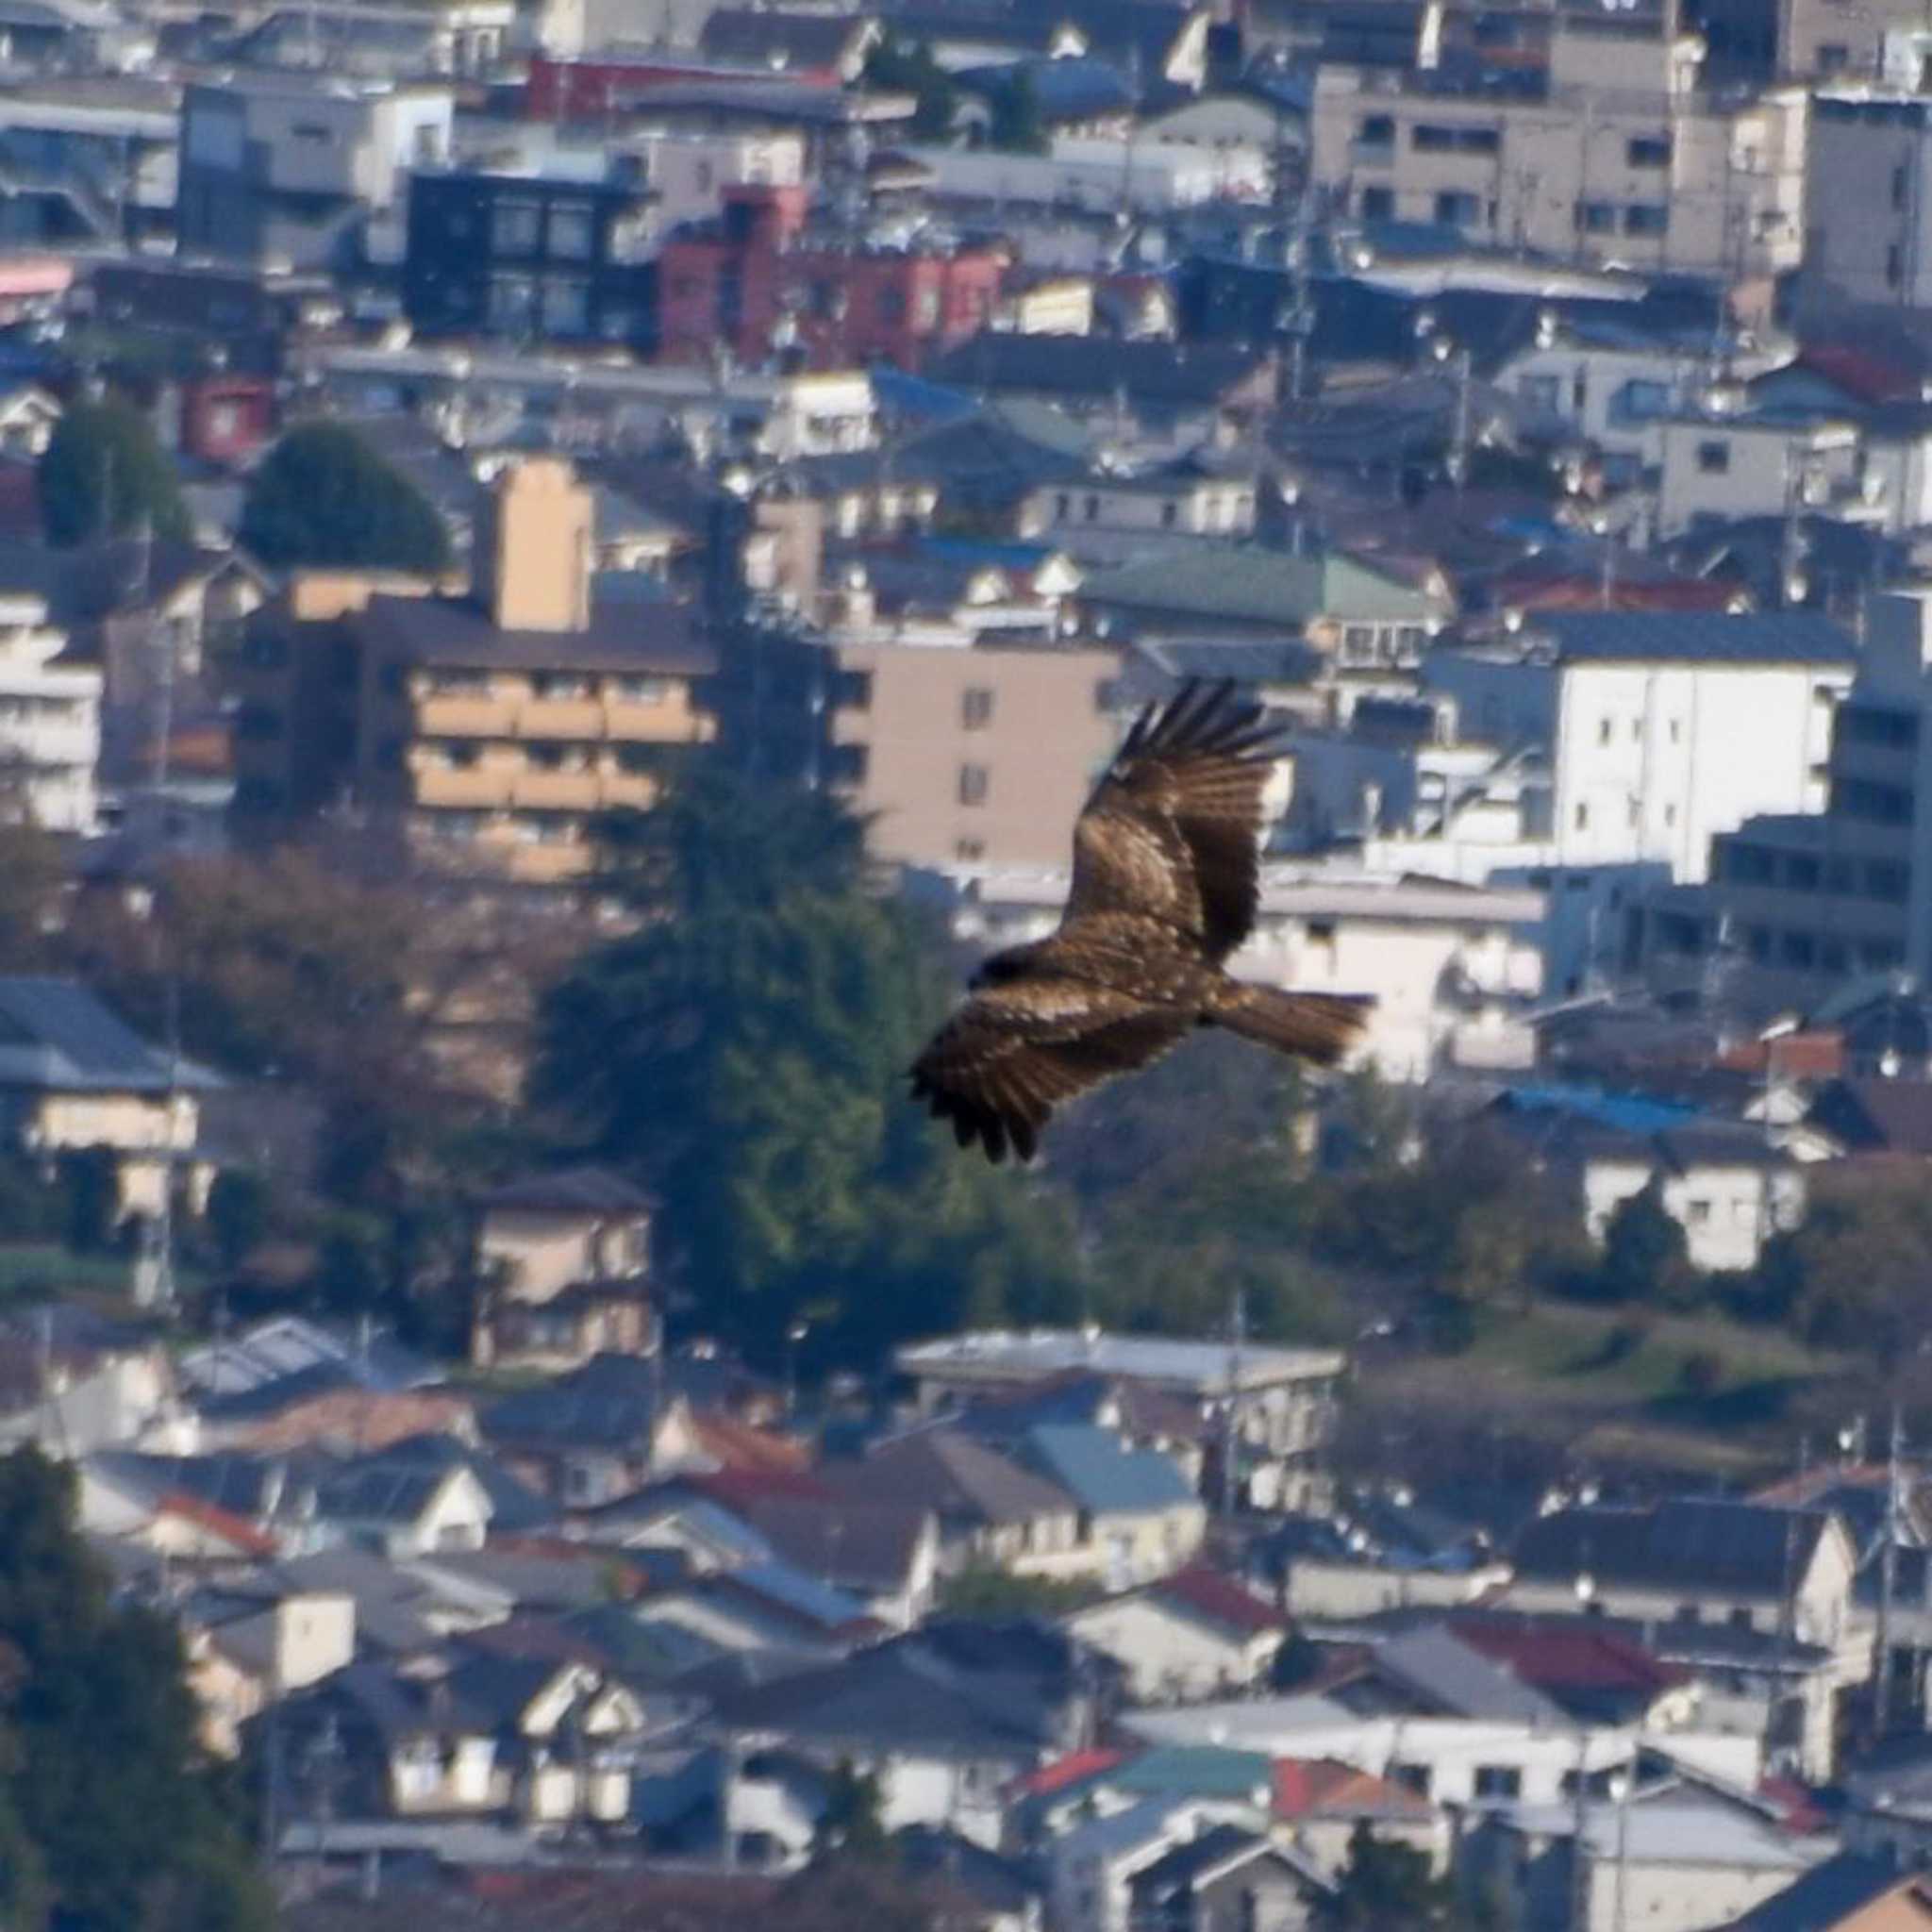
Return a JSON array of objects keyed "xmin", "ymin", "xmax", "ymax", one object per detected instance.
[{"xmin": 831, "ymin": 643, "xmax": 1121, "ymax": 868}]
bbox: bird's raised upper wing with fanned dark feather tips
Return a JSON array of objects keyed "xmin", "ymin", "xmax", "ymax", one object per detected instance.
[{"xmin": 1064, "ymin": 678, "xmax": 1274, "ymax": 964}]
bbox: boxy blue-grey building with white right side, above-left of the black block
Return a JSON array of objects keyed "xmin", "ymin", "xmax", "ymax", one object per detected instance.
[{"xmin": 174, "ymin": 74, "xmax": 452, "ymax": 269}]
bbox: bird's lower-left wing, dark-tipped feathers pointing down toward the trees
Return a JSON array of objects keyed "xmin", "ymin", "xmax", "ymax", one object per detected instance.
[{"xmin": 912, "ymin": 974, "xmax": 1191, "ymax": 1161}]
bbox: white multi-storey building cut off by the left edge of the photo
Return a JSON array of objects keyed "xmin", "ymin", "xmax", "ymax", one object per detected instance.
[{"xmin": 0, "ymin": 595, "xmax": 100, "ymax": 833}]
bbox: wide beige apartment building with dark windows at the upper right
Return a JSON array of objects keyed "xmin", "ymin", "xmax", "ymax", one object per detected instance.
[{"xmin": 1307, "ymin": 13, "xmax": 1807, "ymax": 293}]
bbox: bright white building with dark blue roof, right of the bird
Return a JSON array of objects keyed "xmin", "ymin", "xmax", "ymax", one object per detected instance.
[{"xmin": 1424, "ymin": 610, "xmax": 1855, "ymax": 883}]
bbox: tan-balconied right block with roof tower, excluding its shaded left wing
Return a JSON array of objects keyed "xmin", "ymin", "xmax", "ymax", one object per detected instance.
[{"xmin": 354, "ymin": 458, "xmax": 715, "ymax": 885}]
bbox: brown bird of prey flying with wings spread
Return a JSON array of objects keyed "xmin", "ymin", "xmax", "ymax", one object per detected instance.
[{"xmin": 912, "ymin": 678, "xmax": 1364, "ymax": 1161}]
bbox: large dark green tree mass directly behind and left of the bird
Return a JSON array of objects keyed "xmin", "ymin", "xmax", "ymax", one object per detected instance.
[{"xmin": 539, "ymin": 767, "xmax": 1073, "ymax": 1358}]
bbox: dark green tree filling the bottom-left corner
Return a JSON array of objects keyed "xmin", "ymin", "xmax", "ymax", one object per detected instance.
[{"xmin": 0, "ymin": 1449, "xmax": 271, "ymax": 1932}]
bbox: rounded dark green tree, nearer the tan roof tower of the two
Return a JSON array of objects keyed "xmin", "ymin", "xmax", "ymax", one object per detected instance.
[{"xmin": 242, "ymin": 424, "xmax": 450, "ymax": 575}]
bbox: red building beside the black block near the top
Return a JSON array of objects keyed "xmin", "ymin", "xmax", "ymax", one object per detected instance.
[{"xmin": 657, "ymin": 188, "xmax": 1007, "ymax": 369}]
